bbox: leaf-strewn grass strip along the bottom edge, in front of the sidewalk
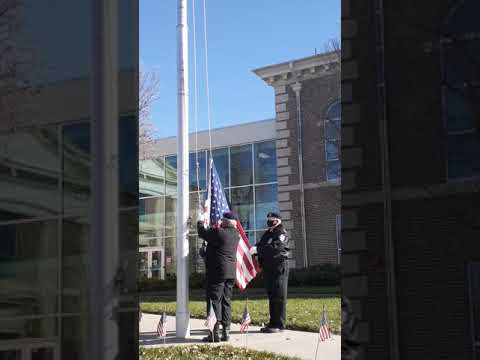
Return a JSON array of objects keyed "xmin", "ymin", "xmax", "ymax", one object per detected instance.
[{"xmin": 140, "ymin": 345, "xmax": 298, "ymax": 360}]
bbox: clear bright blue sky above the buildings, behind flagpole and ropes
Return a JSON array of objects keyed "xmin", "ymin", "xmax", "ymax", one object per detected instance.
[{"xmin": 140, "ymin": 0, "xmax": 340, "ymax": 137}]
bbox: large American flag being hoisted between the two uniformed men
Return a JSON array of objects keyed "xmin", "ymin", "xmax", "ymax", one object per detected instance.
[{"xmin": 204, "ymin": 160, "xmax": 259, "ymax": 290}]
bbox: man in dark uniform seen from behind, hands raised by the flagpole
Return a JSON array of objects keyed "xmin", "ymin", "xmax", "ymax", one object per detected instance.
[{"xmin": 197, "ymin": 212, "xmax": 239, "ymax": 342}]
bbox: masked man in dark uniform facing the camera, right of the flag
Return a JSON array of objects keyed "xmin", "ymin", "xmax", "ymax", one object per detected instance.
[{"xmin": 257, "ymin": 212, "xmax": 289, "ymax": 333}]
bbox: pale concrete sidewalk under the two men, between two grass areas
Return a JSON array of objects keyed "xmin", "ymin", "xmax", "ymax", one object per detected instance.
[{"xmin": 140, "ymin": 314, "xmax": 341, "ymax": 360}]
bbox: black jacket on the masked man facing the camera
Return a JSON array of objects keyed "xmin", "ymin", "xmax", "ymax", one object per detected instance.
[{"xmin": 257, "ymin": 224, "xmax": 290, "ymax": 272}]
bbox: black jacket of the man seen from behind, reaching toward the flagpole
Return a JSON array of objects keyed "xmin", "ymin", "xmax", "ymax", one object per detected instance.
[{"xmin": 197, "ymin": 221, "xmax": 239, "ymax": 282}]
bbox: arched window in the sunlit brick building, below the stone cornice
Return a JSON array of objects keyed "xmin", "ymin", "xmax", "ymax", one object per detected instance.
[{"xmin": 324, "ymin": 100, "xmax": 342, "ymax": 181}]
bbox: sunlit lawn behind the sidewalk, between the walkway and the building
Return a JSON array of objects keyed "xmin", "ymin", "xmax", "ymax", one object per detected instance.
[{"xmin": 141, "ymin": 296, "xmax": 341, "ymax": 334}]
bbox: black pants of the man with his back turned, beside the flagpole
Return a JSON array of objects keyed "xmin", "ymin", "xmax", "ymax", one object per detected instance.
[{"xmin": 207, "ymin": 279, "xmax": 235, "ymax": 328}]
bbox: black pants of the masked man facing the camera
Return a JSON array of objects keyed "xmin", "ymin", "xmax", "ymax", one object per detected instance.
[{"xmin": 264, "ymin": 261, "xmax": 289, "ymax": 329}]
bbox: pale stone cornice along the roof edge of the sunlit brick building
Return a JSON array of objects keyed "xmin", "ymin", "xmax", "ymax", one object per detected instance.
[{"xmin": 253, "ymin": 52, "xmax": 340, "ymax": 86}]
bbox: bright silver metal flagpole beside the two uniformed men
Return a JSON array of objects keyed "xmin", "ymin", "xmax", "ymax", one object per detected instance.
[{"xmin": 175, "ymin": 0, "xmax": 190, "ymax": 339}]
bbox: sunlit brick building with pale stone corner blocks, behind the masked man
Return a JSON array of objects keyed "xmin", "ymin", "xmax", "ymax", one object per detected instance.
[{"xmin": 254, "ymin": 52, "xmax": 341, "ymax": 267}]
